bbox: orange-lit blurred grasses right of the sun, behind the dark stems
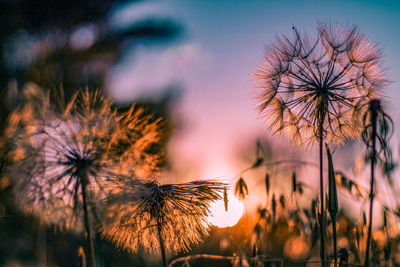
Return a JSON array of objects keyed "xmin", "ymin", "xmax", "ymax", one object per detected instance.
[{"xmin": 199, "ymin": 141, "xmax": 400, "ymax": 267}]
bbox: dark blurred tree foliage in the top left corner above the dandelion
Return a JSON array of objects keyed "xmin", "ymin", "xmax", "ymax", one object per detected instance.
[{"xmin": 0, "ymin": 0, "xmax": 182, "ymax": 140}]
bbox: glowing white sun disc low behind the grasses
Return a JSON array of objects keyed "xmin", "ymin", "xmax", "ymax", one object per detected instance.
[{"xmin": 208, "ymin": 191, "xmax": 244, "ymax": 228}]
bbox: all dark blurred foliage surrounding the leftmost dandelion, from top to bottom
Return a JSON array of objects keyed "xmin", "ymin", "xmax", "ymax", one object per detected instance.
[{"xmin": 0, "ymin": 0, "xmax": 183, "ymax": 266}]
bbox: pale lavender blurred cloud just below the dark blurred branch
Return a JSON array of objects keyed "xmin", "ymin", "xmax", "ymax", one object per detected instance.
[{"xmin": 108, "ymin": 43, "xmax": 211, "ymax": 101}]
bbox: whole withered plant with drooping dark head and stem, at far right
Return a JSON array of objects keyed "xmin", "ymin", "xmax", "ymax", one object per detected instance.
[{"xmin": 362, "ymin": 99, "xmax": 393, "ymax": 267}]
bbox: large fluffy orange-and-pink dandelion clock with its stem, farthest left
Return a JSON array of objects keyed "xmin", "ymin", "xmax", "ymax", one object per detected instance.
[{"xmin": 7, "ymin": 86, "xmax": 162, "ymax": 267}]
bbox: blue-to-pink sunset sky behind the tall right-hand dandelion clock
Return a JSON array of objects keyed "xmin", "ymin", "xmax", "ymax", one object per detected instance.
[{"xmin": 109, "ymin": 0, "xmax": 400, "ymax": 184}]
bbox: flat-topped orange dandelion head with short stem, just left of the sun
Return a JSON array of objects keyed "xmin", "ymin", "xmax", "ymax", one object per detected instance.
[{"xmin": 103, "ymin": 178, "xmax": 225, "ymax": 266}]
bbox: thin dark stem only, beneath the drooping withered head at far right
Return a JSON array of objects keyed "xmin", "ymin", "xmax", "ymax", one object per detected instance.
[{"xmin": 364, "ymin": 104, "xmax": 378, "ymax": 267}]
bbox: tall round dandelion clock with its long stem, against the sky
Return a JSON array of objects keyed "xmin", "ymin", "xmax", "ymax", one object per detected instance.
[{"xmin": 255, "ymin": 23, "xmax": 387, "ymax": 266}]
